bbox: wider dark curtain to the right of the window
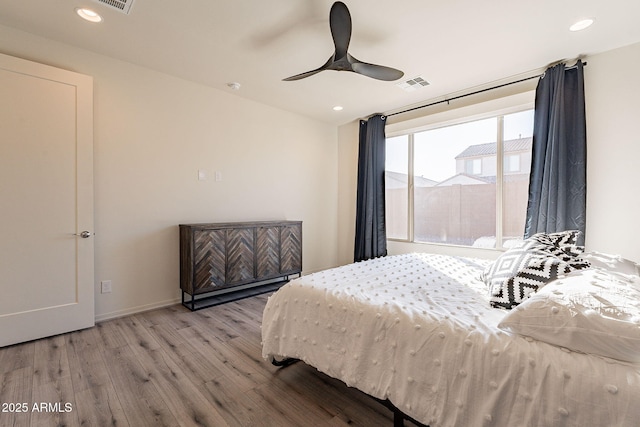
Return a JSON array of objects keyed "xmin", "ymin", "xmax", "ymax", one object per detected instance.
[{"xmin": 524, "ymin": 61, "xmax": 587, "ymax": 244}]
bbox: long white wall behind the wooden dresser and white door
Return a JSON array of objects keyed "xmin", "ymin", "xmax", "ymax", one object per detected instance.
[{"xmin": 0, "ymin": 26, "xmax": 338, "ymax": 320}]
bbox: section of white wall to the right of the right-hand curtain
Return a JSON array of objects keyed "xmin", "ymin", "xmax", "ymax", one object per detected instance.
[{"xmin": 584, "ymin": 43, "xmax": 640, "ymax": 262}]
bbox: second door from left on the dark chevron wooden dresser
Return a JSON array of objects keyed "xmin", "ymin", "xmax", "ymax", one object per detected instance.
[{"xmin": 226, "ymin": 228, "xmax": 255, "ymax": 285}]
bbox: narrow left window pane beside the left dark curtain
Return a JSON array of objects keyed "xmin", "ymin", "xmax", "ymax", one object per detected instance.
[{"xmin": 385, "ymin": 135, "xmax": 409, "ymax": 240}]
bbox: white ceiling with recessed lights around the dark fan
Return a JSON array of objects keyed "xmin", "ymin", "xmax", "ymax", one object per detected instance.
[{"xmin": 0, "ymin": 0, "xmax": 640, "ymax": 125}]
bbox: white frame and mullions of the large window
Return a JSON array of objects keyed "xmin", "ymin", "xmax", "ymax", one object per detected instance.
[{"xmin": 386, "ymin": 100, "xmax": 534, "ymax": 252}]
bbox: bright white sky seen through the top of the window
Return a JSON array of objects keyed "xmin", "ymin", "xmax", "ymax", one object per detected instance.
[{"xmin": 386, "ymin": 110, "xmax": 533, "ymax": 181}]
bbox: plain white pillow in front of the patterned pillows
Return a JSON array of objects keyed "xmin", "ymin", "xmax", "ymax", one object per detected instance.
[{"xmin": 498, "ymin": 269, "xmax": 640, "ymax": 363}]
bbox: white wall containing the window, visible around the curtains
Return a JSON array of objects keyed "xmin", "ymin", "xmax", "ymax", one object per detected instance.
[{"xmin": 338, "ymin": 44, "xmax": 640, "ymax": 263}]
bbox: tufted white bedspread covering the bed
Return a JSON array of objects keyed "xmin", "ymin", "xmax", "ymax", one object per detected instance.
[{"xmin": 262, "ymin": 254, "xmax": 640, "ymax": 427}]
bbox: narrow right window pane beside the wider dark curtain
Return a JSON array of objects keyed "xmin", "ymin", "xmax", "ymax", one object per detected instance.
[{"xmin": 502, "ymin": 110, "xmax": 533, "ymax": 247}]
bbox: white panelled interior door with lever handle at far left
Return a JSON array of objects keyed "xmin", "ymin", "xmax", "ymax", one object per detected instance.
[{"xmin": 0, "ymin": 55, "xmax": 95, "ymax": 346}]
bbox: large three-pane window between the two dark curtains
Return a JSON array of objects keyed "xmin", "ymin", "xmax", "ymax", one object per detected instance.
[{"xmin": 386, "ymin": 110, "xmax": 533, "ymax": 248}]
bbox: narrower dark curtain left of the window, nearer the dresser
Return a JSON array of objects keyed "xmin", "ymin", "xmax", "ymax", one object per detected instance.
[{"xmin": 353, "ymin": 115, "xmax": 387, "ymax": 262}]
